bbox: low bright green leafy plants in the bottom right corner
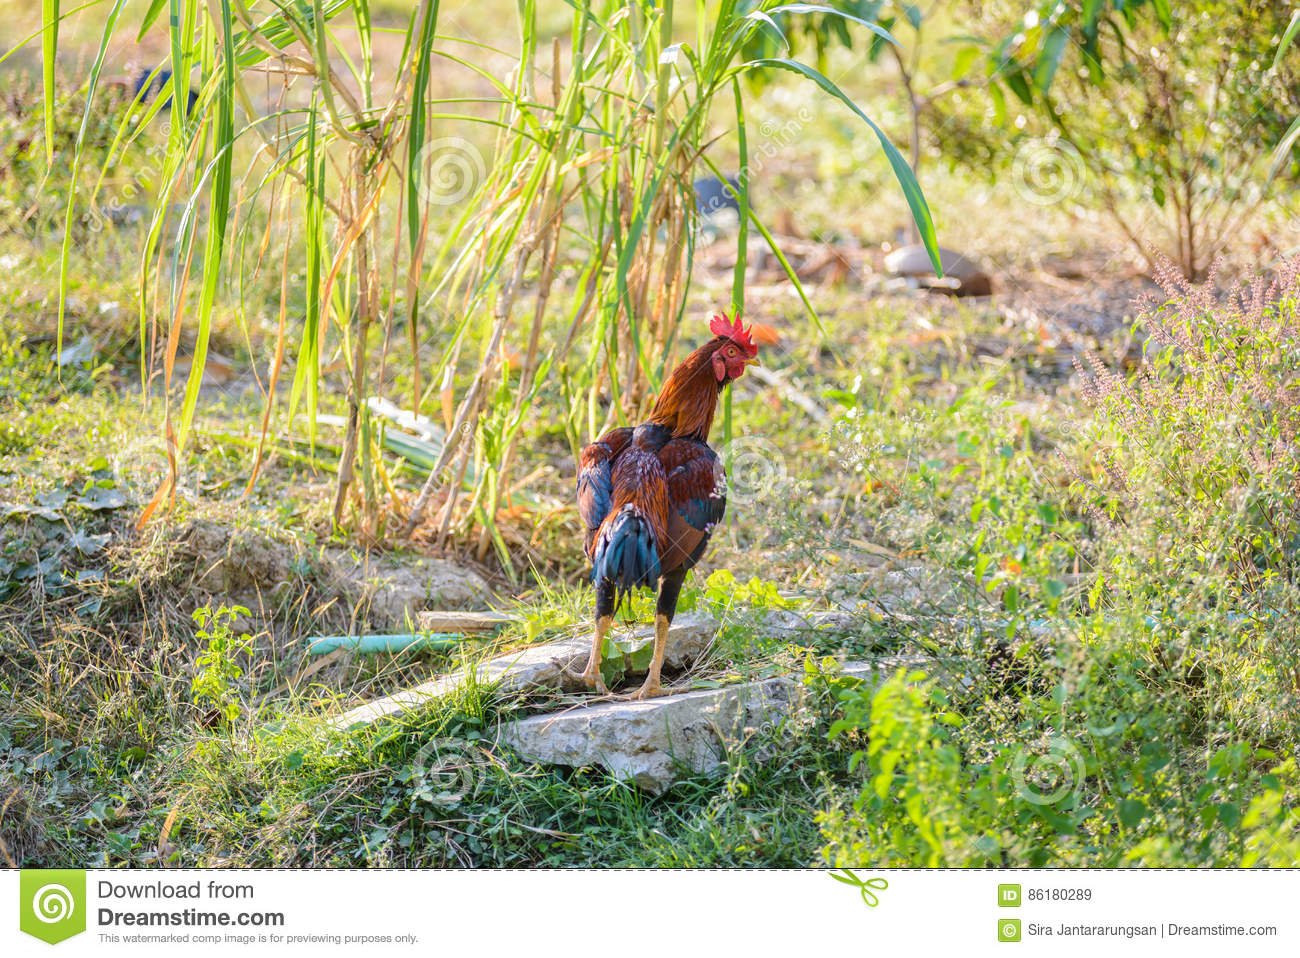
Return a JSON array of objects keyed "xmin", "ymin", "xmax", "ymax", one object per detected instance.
[{"xmin": 818, "ymin": 665, "xmax": 1300, "ymax": 867}]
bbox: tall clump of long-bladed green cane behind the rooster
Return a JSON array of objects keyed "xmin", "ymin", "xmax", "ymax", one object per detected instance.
[{"xmin": 44, "ymin": 0, "xmax": 939, "ymax": 571}]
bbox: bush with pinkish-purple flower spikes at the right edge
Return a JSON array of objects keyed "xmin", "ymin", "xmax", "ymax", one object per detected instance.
[{"xmin": 1080, "ymin": 254, "xmax": 1300, "ymax": 594}]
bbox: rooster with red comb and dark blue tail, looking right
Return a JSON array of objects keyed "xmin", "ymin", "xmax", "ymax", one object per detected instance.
[{"xmin": 577, "ymin": 313, "xmax": 759, "ymax": 699}]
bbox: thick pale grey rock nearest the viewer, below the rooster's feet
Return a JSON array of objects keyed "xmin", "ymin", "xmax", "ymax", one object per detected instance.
[{"xmin": 501, "ymin": 656, "xmax": 923, "ymax": 794}]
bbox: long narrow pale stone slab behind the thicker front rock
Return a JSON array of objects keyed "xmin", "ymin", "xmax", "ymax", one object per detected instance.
[{"xmin": 330, "ymin": 612, "xmax": 718, "ymax": 728}]
